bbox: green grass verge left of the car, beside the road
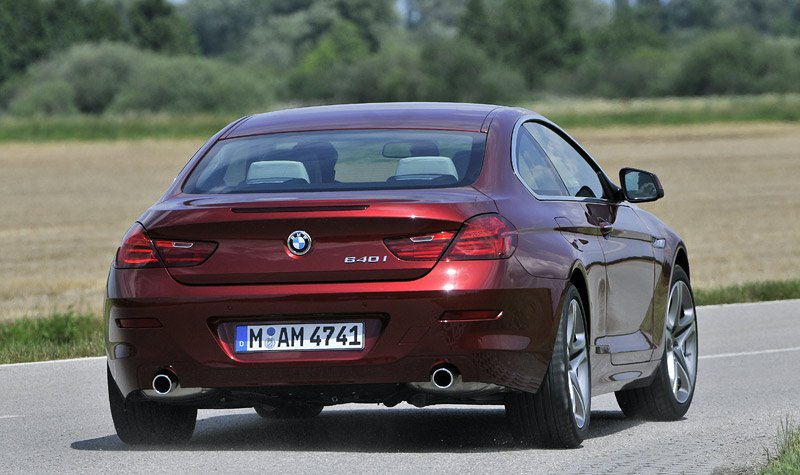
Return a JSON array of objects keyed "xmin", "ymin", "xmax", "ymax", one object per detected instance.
[{"xmin": 0, "ymin": 312, "xmax": 105, "ymax": 364}]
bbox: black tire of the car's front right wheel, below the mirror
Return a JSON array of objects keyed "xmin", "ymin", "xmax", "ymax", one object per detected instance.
[{"xmin": 614, "ymin": 266, "xmax": 697, "ymax": 421}]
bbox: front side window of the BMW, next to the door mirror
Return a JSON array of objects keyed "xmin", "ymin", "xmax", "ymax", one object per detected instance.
[{"xmin": 524, "ymin": 122, "xmax": 605, "ymax": 198}]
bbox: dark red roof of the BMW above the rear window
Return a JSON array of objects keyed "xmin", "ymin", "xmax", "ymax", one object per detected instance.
[{"xmin": 223, "ymin": 102, "xmax": 530, "ymax": 138}]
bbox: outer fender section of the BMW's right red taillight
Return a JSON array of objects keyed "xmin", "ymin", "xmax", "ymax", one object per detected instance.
[{"xmin": 445, "ymin": 214, "xmax": 517, "ymax": 261}]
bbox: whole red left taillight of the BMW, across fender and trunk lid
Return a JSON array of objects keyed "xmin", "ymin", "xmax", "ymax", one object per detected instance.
[{"xmin": 114, "ymin": 223, "xmax": 217, "ymax": 269}]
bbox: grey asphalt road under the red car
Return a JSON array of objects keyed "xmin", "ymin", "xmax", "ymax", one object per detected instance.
[{"xmin": 0, "ymin": 300, "xmax": 800, "ymax": 474}]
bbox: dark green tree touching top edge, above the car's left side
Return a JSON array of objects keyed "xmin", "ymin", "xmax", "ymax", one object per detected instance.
[{"xmin": 128, "ymin": 0, "xmax": 198, "ymax": 54}]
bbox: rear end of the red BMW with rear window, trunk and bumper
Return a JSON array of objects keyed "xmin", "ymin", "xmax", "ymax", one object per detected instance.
[{"xmin": 106, "ymin": 107, "xmax": 564, "ymax": 407}]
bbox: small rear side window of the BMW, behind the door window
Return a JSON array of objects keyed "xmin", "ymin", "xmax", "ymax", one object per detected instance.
[{"xmin": 517, "ymin": 128, "xmax": 568, "ymax": 196}]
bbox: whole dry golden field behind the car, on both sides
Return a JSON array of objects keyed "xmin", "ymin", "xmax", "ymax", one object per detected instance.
[{"xmin": 0, "ymin": 124, "xmax": 800, "ymax": 320}]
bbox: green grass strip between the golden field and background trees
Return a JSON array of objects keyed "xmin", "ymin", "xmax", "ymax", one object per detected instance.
[{"xmin": 0, "ymin": 94, "xmax": 800, "ymax": 142}]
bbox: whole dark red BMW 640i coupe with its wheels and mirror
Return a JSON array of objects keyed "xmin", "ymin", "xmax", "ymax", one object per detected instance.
[{"xmin": 105, "ymin": 103, "xmax": 697, "ymax": 447}]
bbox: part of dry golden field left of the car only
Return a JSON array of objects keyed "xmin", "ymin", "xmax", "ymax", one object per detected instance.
[{"xmin": 0, "ymin": 140, "xmax": 202, "ymax": 319}]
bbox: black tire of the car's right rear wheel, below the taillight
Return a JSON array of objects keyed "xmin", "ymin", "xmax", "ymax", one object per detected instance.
[{"xmin": 506, "ymin": 285, "xmax": 591, "ymax": 448}]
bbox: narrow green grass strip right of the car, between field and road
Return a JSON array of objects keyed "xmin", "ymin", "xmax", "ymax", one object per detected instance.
[{"xmin": 694, "ymin": 279, "xmax": 800, "ymax": 305}]
